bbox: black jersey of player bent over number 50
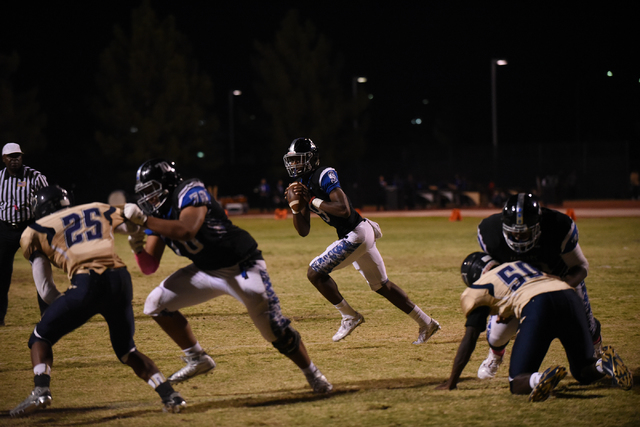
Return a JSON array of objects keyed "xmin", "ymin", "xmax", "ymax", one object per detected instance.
[{"xmin": 478, "ymin": 208, "xmax": 578, "ymax": 277}]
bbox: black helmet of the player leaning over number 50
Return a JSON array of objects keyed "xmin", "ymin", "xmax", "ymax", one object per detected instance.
[{"xmin": 502, "ymin": 193, "xmax": 542, "ymax": 254}]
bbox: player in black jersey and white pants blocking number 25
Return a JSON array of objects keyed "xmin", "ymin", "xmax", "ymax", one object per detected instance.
[{"xmin": 124, "ymin": 159, "xmax": 333, "ymax": 393}]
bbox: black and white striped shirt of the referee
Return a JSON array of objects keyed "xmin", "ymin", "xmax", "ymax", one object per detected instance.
[{"xmin": 0, "ymin": 165, "xmax": 49, "ymax": 223}]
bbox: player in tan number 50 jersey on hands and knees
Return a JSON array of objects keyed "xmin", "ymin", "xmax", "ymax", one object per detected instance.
[{"xmin": 436, "ymin": 252, "xmax": 633, "ymax": 402}]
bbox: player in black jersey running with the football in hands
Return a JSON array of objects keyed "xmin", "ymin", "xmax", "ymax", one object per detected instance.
[{"xmin": 283, "ymin": 138, "xmax": 440, "ymax": 344}]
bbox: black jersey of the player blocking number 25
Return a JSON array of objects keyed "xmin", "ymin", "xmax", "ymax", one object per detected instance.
[{"xmin": 154, "ymin": 179, "xmax": 262, "ymax": 270}]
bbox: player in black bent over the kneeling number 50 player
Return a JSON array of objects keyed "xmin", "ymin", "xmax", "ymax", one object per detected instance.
[{"xmin": 478, "ymin": 193, "xmax": 602, "ymax": 379}]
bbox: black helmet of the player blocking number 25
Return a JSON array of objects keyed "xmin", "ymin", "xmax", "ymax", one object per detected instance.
[{"xmin": 135, "ymin": 159, "xmax": 182, "ymax": 216}]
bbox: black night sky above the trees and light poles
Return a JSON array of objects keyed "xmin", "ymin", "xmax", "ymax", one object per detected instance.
[{"xmin": 0, "ymin": 0, "xmax": 640, "ymax": 201}]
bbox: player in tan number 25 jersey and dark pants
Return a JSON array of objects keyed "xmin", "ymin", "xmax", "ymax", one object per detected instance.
[{"xmin": 10, "ymin": 186, "xmax": 186, "ymax": 417}]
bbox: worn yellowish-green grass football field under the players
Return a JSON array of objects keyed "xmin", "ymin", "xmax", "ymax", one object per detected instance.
[{"xmin": 0, "ymin": 217, "xmax": 640, "ymax": 427}]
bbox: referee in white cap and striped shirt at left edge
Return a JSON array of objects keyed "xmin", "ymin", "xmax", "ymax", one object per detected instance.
[{"xmin": 0, "ymin": 142, "xmax": 48, "ymax": 326}]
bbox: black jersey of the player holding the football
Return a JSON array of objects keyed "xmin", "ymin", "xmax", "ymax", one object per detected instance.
[{"xmin": 303, "ymin": 167, "xmax": 364, "ymax": 239}]
